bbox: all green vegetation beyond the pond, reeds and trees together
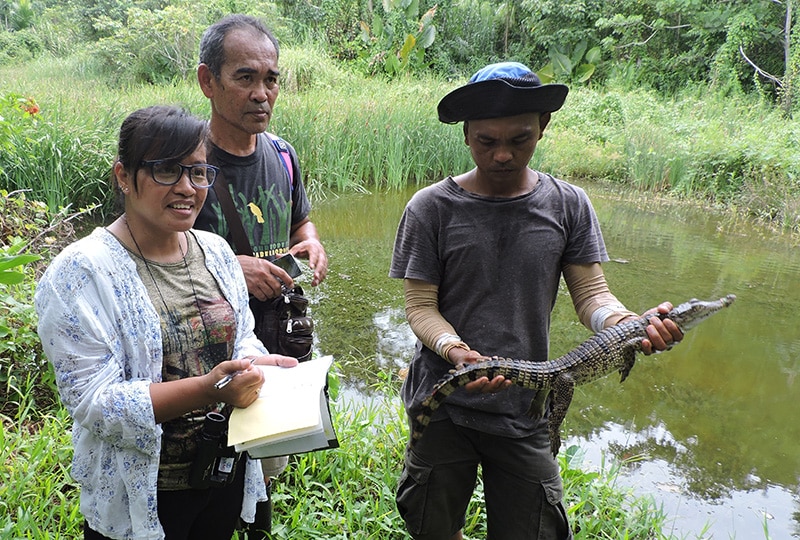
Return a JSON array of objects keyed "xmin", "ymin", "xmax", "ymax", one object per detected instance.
[{"xmin": 0, "ymin": 0, "xmax": 800, "ymax": 230}]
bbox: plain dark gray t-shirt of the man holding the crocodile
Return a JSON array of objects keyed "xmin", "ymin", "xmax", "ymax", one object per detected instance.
[{"xmin": 389, "ymin": 173, "xmax": 608, "ymax": 437}]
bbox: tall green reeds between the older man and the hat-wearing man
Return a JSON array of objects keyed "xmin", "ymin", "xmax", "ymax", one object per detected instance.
[{"xmin": 276, "ymin": 75, "xmax": 472, "ymax": 190}]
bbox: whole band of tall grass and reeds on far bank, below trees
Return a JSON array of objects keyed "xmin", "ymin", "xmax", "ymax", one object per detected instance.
[{"xmin": 0, "ymin": 45, "xmax": 800, "ymax": 232}]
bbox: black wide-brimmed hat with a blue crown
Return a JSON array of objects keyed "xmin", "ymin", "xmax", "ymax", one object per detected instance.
[{"xmin": 437, "ymin": 62, "xmax": 569, "ymax": 124}]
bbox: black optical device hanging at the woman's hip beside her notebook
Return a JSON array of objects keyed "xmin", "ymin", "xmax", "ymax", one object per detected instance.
[{"xmin": 189, "ymin": 412, "xmax": 240, "ymax": 489}]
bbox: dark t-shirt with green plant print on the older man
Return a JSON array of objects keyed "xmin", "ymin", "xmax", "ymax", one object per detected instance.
[{"xmin": 194, "ymin": 133, "xmax": 311, "ymax": 259}]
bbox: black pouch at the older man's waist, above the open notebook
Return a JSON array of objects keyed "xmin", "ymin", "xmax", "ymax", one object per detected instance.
[{"xmin": 250, "ymin": 285, "xmax": 314, "ymax": 362}]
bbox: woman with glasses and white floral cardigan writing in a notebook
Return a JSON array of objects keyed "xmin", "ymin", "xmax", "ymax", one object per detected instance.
[{"xmin": 35, "ymin": 106, "xmax": 297, "ymax": 540}]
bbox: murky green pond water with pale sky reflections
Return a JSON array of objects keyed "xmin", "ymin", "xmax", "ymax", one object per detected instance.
[{"xmin": 309, "ymin": 184, "xmax": 800, "ymax": 540}]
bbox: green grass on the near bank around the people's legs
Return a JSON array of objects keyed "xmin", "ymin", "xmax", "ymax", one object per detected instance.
[{"xmin": 0, "ymin": 372, "xmax": 680, "ymax": 540}]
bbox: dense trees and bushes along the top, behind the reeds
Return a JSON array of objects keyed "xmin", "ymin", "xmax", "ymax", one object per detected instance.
[{"xmin": 0, "ymin": 0, "xmax": 800, "ymax": 99}]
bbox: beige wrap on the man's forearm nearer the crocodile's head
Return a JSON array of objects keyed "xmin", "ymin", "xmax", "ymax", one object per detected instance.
[{"xmin": 562, "ymin": 263, "xmax": 638, "ymax": 332}]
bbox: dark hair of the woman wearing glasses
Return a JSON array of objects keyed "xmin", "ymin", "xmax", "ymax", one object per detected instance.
[{"xmin": 114, "ymin": 105, "xmax": 208, "ymax": 190}]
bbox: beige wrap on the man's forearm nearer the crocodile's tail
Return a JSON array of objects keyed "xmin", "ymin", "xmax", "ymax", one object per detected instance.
[{"xmin": 403, "ymin": 279, "xmax": 469, "ymax": 362}]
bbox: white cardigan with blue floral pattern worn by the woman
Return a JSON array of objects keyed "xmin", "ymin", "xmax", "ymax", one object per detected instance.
[{"xmin": 35, "ymin": 228, "xmax": 266, "ymax": 539}]
